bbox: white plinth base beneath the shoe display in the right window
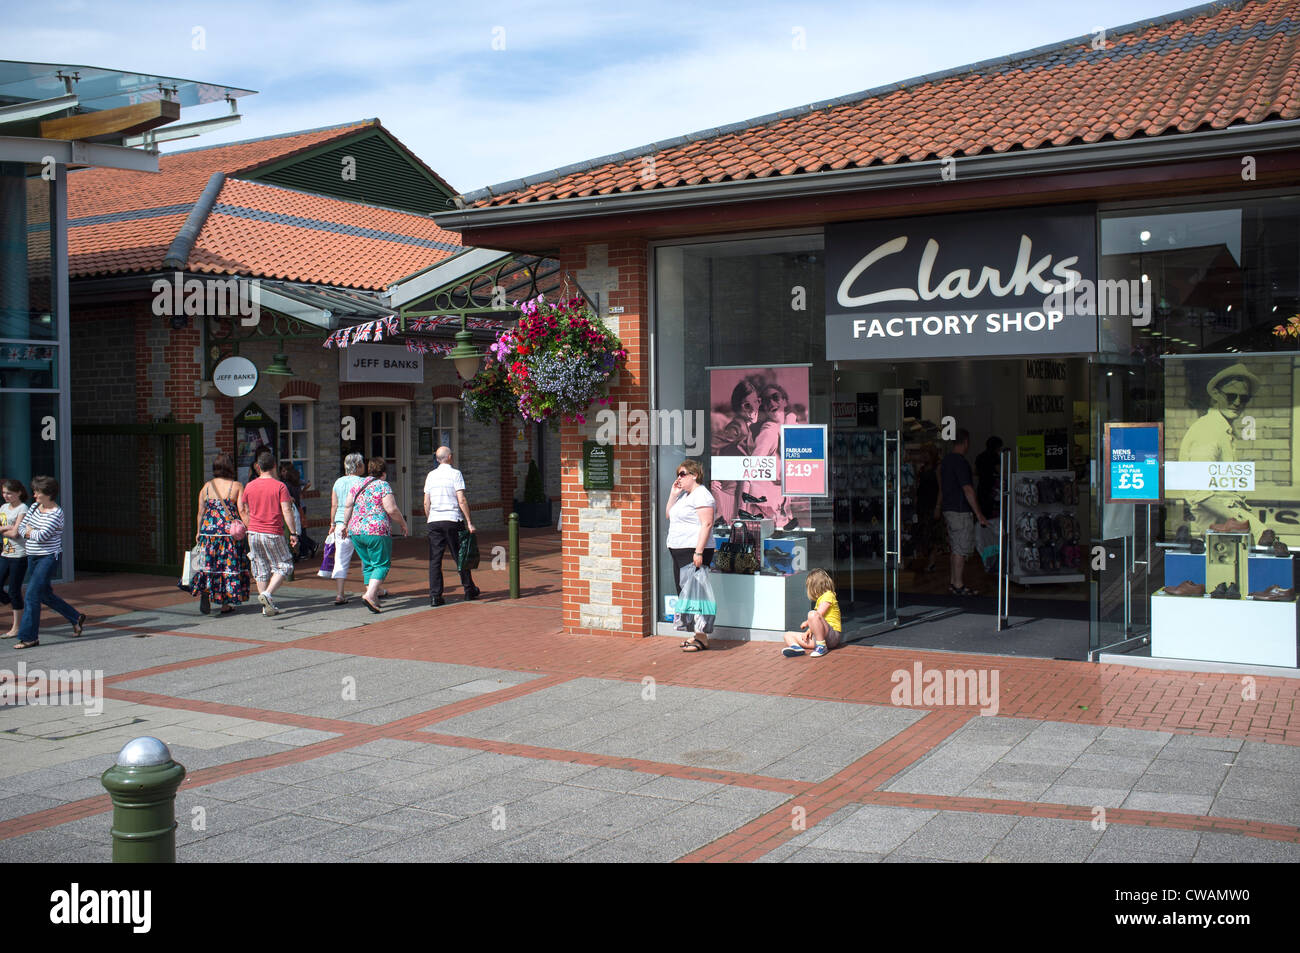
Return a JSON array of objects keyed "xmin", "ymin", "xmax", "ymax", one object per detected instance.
[{"xmin": 1151, "ymin": 593, "xmax": 1297, "ymax": 668}]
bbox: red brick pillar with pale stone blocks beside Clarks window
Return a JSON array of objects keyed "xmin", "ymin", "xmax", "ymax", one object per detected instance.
[{"xmin": 560, "ymin": 241, "xmax": 655, "ymax": 638}]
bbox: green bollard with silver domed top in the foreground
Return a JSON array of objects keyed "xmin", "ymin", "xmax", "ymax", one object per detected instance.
[{"xmin": 99, "ymin": 737, "xmax": 185, "ymax": 863}]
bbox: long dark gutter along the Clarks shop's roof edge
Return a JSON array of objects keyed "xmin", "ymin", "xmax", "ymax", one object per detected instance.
[{"xmin": 434, "ymin": 120, "xmax": 1300, "ymax": 231}]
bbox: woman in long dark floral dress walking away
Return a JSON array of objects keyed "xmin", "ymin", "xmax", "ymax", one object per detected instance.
[{"xmin": 190, "ymin": 454, "xmax": 248, "ymax": 615}]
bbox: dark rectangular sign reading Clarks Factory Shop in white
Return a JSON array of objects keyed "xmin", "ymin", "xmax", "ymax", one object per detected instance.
[{"xmin": 826, "ymin": 205, "xmax": 1097, "ymax": 360}]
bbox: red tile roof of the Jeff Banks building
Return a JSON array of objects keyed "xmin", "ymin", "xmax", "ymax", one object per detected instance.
[{"xmin": 68, "ymin": 120, "xmax": 462, "ymax": 290}]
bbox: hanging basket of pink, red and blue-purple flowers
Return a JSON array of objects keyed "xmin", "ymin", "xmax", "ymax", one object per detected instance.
[{"xmin": 465, "ymin": 289, "xmax": 628, "ymax": 424}]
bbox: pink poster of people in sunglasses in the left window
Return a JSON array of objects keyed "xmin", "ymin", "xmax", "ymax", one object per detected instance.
[{"xmin": 709, "ymin": 367, "xmax": 811, "ymax": 529}]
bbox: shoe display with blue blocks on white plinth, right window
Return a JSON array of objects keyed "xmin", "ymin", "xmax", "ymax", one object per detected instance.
[{"xmin": 1151, "ymin": 521, "xmax": 1297, "ymax": 668}]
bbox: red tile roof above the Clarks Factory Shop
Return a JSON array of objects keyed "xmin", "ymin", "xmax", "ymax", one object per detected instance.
[{"xmin": 465, "ymin": 0, "xmax": 1300, "ymax": 207}]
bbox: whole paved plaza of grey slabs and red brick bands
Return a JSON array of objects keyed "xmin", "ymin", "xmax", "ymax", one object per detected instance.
[{"xmin": 0, "ymin": 532, "xmax": 1300, "ymax": 863}]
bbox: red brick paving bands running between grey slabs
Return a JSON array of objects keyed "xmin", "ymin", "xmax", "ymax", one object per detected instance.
[{"xmin": 10, "ymin": 530, "xmax": 1300, "ymax": 862}]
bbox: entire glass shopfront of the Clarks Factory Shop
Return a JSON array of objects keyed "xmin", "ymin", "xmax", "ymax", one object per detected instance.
[{"xmin": 654, "ymin": 195, "xmax": 1300, "ymax": 666}]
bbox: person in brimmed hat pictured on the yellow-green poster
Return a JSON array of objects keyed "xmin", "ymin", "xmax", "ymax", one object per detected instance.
[{"xmin": 1178, "ymin": 364, "xmax": 1264, "ymax": 537}]
